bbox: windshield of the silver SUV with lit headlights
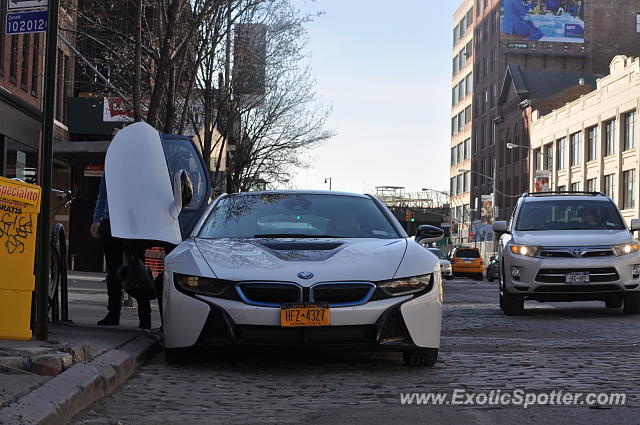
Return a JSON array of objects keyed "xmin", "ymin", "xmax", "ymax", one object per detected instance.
[{"xmin": 516, "ymin": 199, "xmax": 626, "ymax": 231}]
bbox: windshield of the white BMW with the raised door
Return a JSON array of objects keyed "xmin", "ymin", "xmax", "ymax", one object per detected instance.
[{"xmin": 199, "ymin": 193, "xmax": 400, "ymax": 239}]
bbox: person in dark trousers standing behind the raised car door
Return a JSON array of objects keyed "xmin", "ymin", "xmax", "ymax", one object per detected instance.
[{"xmin": 90, "ymin": 175, "xmax": 151, "ymax": 329}]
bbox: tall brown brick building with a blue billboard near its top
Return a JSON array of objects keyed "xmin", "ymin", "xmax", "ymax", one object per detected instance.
[{"xmin": 451, "ymin": 0, "xmax": 640, "ymax": 240}]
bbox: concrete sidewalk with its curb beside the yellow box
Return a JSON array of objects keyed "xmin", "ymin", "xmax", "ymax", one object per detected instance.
[{"xmin": 0, "ymin": 273, "xmax": 159, "ymax": 425}]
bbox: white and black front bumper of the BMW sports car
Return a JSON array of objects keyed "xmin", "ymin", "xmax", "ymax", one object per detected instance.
[{"xmin": 163, "ymin": 273, "xmax": 442, "ymax": 351}]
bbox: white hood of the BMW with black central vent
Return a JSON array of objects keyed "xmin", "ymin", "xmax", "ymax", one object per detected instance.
[{"xmin": 194, "ymin": 239, "xmax": 407, "ymax": 286}]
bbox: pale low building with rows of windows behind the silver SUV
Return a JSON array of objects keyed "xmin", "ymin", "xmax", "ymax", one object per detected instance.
[{"xmin": 529, "ymin": 56, "xmax": 640, "ymax": 225}]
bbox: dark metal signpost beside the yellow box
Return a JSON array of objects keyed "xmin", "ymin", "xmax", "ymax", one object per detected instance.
[{"xmin": 36, "ymin": 0, "xmax": 62, "ymax": 341}]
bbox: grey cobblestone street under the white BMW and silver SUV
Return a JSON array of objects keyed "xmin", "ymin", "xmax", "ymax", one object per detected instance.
[{"xmin": 70, "ymin": 280, "xmax": 640, "ymax": 425}]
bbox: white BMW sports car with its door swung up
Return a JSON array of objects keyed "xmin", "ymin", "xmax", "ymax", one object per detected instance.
[{"xmin": 106, "ymin": 123, "xmax": 443, "ymax": 366}]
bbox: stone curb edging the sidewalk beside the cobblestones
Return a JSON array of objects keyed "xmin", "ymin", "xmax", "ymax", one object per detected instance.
[{"xmin": 0, "ymin": 336, "xmax": 158, "ymax": 425}]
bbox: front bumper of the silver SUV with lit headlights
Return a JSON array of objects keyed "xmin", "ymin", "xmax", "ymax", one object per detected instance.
[{"xmin": 503, "ymin": 252, "xmax": 640, "ymax": 301}]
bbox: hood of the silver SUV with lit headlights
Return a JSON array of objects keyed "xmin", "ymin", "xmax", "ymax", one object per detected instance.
[{"xmin": 512, "ymin": 230, "xmax": 633, "ymax": 246}]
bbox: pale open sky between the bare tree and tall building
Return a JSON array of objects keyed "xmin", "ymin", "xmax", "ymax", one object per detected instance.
[{"xmin": 291, "ymin": 0, "xmax": 459, "ymax": 193}]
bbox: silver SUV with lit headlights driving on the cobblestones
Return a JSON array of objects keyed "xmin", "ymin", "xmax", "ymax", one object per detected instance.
[{"xmin": 493, "ymin": 192, "xmax": 640, "ymax": 316}]
